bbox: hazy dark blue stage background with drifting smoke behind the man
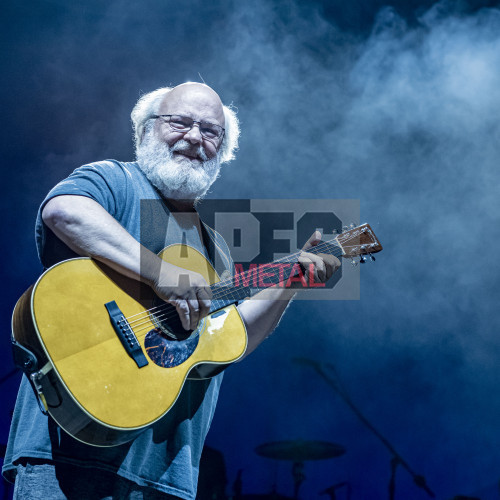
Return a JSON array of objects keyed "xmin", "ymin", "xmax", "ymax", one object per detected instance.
[{"xmin": 0, "ymin": 0, "xmax": 500, "ymax": 499}]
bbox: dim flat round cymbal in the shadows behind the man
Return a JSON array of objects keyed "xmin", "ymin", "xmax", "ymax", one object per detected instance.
[{"xmin": 255, "ymin": 440, "xmax": 346, "ymax": 462}]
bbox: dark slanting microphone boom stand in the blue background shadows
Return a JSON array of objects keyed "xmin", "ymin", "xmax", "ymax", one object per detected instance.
[{"xmin": 295, "ymin": 358, "xmax": 436, "ymax": 500}]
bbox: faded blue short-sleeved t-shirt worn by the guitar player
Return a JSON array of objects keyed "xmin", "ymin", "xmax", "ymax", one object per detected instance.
[{"xmin": 2, "ymin": 160, "xmax": 232, "ymax": 499}]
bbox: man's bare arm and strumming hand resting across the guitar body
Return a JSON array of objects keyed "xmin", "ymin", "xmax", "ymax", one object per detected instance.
[{"xmin": 42, "ymin": 195, "xmax": 210, "ymax": 329}]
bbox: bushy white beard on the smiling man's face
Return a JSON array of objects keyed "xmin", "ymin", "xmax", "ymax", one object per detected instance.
[{"xmin": 137, "ymin": 129, "xmax": 220, "ymax": 201}]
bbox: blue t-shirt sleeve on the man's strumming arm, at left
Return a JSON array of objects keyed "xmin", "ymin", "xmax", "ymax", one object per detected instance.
[{"xmin": 35, "ymin": 161, "xmax": 128, "ymax": 268}]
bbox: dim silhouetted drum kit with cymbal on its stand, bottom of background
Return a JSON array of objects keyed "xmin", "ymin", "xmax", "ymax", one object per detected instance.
[{"xmin": 233, "ymin": 440, "xmax": 347, "ymax": 500}]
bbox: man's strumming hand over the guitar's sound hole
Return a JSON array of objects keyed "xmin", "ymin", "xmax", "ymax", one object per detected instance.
[{"xmin": 152, "ymin": 261, "xmax": 212, "ymax": 330}]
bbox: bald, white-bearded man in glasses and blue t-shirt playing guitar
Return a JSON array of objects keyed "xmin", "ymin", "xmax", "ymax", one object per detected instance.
[{"xmin": 3, "ymin": 83, "xmax": 339, "ymax": 499}]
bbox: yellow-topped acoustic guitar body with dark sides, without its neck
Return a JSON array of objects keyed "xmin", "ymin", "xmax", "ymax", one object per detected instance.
[{"xmin": 12, "ymin": 245, "xmax": 247, "ymax": 446}]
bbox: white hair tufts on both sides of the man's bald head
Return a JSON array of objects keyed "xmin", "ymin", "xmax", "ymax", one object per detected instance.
[{"xmin": 130, "ymin": 87, "xmax": 240, "ymax": 163}]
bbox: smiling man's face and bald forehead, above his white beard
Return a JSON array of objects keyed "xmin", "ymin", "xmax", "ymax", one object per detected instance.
[{"xmin": 154, "ymin": 83, "xmax": 224, "ymax": 166}]
